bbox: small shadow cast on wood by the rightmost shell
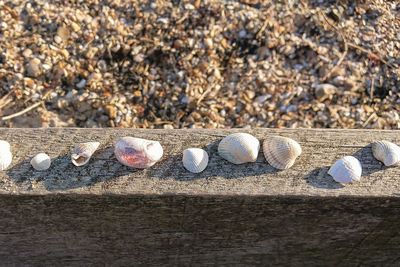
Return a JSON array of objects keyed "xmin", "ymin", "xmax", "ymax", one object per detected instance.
[{"xmin": 353, "ymin": 144, "xmax": 391, "ymax": 176}]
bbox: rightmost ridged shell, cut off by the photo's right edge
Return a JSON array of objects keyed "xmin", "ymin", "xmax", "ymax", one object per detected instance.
[{"xmin": 372, "ymin": 140, "xmax": 400, "ymax": 166}]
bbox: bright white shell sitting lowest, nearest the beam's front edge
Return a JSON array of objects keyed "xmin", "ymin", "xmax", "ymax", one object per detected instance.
[{"xmin": 328, "ymin": 156, "xmax": 362, "ymax": 183}]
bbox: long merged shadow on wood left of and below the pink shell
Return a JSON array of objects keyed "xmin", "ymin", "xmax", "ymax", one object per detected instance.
[{"xmin": 6, "ymin": 147, "xmax": 139, "ymax": 191}]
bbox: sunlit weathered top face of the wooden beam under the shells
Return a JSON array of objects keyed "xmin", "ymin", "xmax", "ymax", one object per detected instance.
[{"xmin": 0, "ymin": 128, "xmax": 400, "ymax": 197}]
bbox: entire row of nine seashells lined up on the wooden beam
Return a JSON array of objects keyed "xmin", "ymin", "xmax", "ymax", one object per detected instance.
[{"xmin": 0, "ymin": 133, "xmax": 400, "ymax": 183}]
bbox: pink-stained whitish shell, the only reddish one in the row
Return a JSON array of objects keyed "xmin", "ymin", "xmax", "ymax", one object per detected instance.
[{"xmin": 114, "ymin": 136, "xmax": 163, "ymax": 169}]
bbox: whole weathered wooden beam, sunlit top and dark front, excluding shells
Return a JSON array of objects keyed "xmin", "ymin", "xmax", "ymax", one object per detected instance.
[{"xmin": 0, "ymin": 128, "xmax": 400, "ymax": 266}]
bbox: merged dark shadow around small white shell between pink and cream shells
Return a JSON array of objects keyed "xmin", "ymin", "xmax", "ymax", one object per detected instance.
[{"xmin": 147, "ymin": 140, "xmax": 279, "ymax": 181}]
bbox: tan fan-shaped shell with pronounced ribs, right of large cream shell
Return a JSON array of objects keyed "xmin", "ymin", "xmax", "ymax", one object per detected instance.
[{"xmin": 263, "ymin": 136, "xmax": 301, "ymax": 170}]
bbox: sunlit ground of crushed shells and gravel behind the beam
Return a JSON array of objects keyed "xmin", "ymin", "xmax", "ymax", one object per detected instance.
[{"xmin": 0, "ymin": 0, "xmax": 400, "ymax": 129}]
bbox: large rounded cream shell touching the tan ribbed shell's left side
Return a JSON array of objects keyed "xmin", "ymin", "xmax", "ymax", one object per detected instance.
[{"xmin": 218, "ymin": 133, "xmax": 260, "ymax": 164}]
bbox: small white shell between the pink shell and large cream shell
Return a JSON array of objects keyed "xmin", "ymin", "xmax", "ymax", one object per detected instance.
[{"xmin": 182, "ymin": 148, "xmax": 208, "ymax": 173}]
